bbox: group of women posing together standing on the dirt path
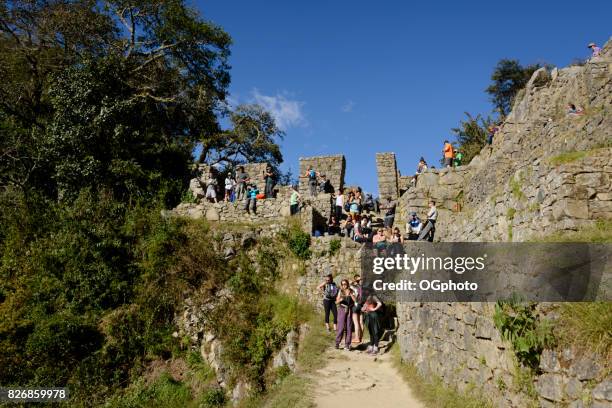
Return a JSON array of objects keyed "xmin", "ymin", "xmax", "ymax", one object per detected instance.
[{"xmin": 318, "ymin": 274, "xmax": 383, "ymax": 354}]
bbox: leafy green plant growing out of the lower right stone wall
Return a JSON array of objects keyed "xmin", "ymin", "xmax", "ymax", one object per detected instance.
[{"xmin": 493, "ymin": 297, "xmax": 555, "ymax": 370}]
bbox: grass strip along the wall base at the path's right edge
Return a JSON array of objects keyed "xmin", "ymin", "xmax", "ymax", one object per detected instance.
[{"xmin": 391, "ymin": 345, "xmax": 493, "ymax": 408}]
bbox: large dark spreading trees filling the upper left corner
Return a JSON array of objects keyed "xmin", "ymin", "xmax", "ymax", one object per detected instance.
[{"xmin": 0, "ymin": 0, "xmax": 231, "ymax": 204}]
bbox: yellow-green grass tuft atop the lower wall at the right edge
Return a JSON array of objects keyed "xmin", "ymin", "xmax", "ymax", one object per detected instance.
[{"xmin": 555, "ymin": 302, "xmax": 612, "ymax": 361}]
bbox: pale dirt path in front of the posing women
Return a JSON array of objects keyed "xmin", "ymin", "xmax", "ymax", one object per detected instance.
[{"xmin": 313, "ymin": 340, "xmax": 424, "ymax": 408}]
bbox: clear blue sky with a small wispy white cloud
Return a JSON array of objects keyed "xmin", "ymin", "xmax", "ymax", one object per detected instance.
[{"xmin": 192, "ymin": 0, "xmax": 612, "ymax": 193}]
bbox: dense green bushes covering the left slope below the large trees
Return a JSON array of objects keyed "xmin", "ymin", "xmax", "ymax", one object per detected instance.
[{"xmin": 0, "ymin": 190, "xmax": 227, "ymax": 402}]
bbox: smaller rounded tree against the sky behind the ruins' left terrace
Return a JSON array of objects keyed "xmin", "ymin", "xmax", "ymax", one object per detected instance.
[{"xmin": 200, "ymin": 105, "xmax": 284, "ymax": 167}]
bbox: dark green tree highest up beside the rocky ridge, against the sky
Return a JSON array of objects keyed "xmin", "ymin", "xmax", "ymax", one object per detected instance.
[{"xmin": 486, "ymin": 59, "xmax": 541, "ymax": 117}]
